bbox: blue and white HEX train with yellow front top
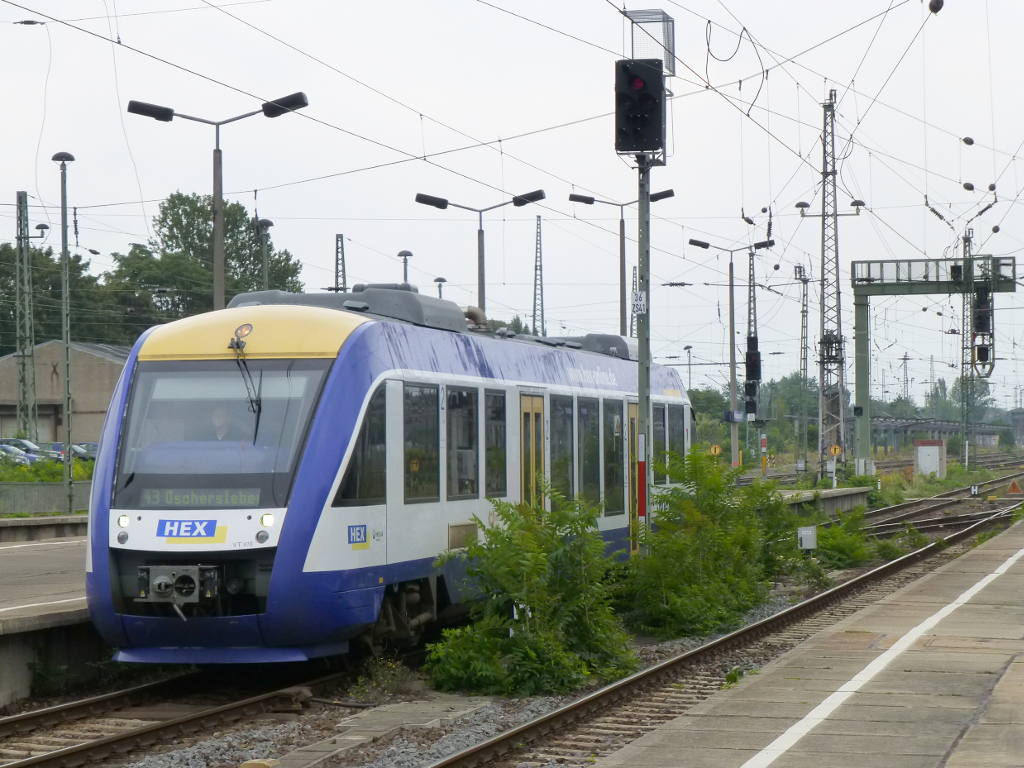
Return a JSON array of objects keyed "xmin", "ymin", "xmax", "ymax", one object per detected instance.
[{"xmin": 86, "ymin": 286, "xmax": 692, "ymax": 664}]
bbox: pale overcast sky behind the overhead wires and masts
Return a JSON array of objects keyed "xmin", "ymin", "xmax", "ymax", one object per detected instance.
[{"xmin": 0, "ymin": 0, "xmax": 1024, "ymax": 407}]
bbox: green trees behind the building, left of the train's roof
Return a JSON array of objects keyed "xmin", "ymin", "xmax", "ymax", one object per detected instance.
[{"xmin": 0, "ymin": 193, "xmax": 302, "ymax": 354}]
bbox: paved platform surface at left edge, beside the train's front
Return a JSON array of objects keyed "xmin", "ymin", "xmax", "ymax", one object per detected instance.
[{"xmin": 0, "ymin": 538, "xmax": 88, "ymax": 635}]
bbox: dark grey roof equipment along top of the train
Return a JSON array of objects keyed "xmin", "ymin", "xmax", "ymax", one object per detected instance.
[{"xmin": 227, "ymin": 283, "xmax": 638, "ymax": 361}]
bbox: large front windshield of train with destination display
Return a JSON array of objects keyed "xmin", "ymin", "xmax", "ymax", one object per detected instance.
[{"xmin": 114, "ymin": 359, "xmax": 331, "ymax": 509}]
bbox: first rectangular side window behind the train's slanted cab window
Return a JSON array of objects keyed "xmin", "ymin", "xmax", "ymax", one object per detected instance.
[{"xmin": 402, "ymin": 384, "xmax": 440, "ymax": 504}]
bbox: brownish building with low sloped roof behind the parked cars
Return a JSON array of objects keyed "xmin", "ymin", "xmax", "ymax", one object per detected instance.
[{"xmin": 0, "ymin": 339, "xmax": 129, "ymax": 442}]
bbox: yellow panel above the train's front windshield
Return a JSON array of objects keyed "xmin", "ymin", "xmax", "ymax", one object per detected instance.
[{"xmin": 138, "ymin": 304, "xmax": 368, "ymax": 360}]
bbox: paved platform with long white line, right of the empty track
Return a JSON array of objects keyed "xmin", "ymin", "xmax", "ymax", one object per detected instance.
[{"xmin": 595, "ymin": 523, "xmax": 1024, "ymax": 768}]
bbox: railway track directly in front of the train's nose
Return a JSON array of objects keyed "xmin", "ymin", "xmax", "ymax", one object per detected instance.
[{"xmin": 0, "ymin": 673, "xmax": 345, "ymax": 768}]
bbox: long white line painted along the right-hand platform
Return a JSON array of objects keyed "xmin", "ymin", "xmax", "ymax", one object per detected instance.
[{"xmin": 740, "ymin": 532, "xmax": 1024, "ymax": 768}]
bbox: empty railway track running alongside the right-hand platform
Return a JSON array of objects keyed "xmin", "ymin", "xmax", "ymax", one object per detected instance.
[{"xmin": 419, "ymin": 504, "xmax": 1020, "ymax": 768}]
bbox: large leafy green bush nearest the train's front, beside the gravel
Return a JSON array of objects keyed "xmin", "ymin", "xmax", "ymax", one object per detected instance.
[{"xmin": 426, "ymin": 492, "xmax": 636, "ymax": 695}]
